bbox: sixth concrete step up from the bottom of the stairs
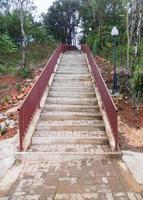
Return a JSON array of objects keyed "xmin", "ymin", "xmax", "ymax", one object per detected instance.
[{"xmin": 46, "ymin": 97, "xmax": 98, "ymax": 106}]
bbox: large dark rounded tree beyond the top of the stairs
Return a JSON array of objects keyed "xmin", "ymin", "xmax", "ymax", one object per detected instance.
[{"xmin": 43, "ymin": 0, "xmax": 80, "ymax": 44}]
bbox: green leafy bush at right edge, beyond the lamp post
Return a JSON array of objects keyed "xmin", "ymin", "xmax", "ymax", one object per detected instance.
[{"xmin": 131, "ymin": 66, "xmax": 143, "ymax": 102}]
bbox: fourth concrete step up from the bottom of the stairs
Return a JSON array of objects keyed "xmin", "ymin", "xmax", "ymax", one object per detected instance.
[{"xmin": 40, "ymin": 111, "xmax": 102, "ymax": 121}]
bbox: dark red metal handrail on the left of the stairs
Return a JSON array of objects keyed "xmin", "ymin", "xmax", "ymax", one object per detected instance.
[{"xmin": 18, "ymin": 44, "xmax": 75, "ymax": 151}]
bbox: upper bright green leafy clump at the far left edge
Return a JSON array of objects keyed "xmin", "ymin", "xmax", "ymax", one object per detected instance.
[{"xmin": 0, "ymin": 34, "xmax": 17, "ymax": 55}]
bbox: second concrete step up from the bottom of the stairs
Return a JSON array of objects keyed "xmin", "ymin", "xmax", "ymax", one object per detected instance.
[{"xmin": 32, "ymin": 136, "xmax": 108, "ymax": 145}]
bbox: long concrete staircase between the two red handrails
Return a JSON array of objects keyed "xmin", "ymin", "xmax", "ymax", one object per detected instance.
[{"xmin": 25, "ymin": 51, "xmax": 118, "ymax": 160}]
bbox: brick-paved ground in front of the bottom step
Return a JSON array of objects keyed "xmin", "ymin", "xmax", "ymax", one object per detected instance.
[{"xmin": 0, "ymin": 159, "xmax": 143, "ymax": 200}]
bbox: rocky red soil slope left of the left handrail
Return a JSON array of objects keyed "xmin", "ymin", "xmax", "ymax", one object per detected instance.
[{"xmin": 0, "ymin": 69, "xmax": 41, "ymax": 140}]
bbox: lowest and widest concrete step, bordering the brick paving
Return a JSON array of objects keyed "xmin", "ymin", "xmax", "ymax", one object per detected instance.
[{"xmin": 15, "ymin": 150, "xmax": 122, "ymax": 162}]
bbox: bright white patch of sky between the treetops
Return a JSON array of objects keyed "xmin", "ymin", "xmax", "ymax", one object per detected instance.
[{"xmin": 34, "ymin": 0, "xmax": 55, "ymax": 14}]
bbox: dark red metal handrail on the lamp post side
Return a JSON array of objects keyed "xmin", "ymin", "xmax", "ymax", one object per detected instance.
[{"xmin": 81, "ymin": 44, "xmax": 118, "ymax": 150}]
